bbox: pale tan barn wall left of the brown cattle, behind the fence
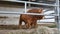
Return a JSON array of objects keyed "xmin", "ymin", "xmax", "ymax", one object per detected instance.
[{"xmin": 0, "ymin": 4, "xmax": 24, "ymax": 25}]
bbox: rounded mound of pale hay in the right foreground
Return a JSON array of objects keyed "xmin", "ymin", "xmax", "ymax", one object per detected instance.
[{"xmin": 37, "ymin": 26, "xmax": 54, "ymax": 34}]
